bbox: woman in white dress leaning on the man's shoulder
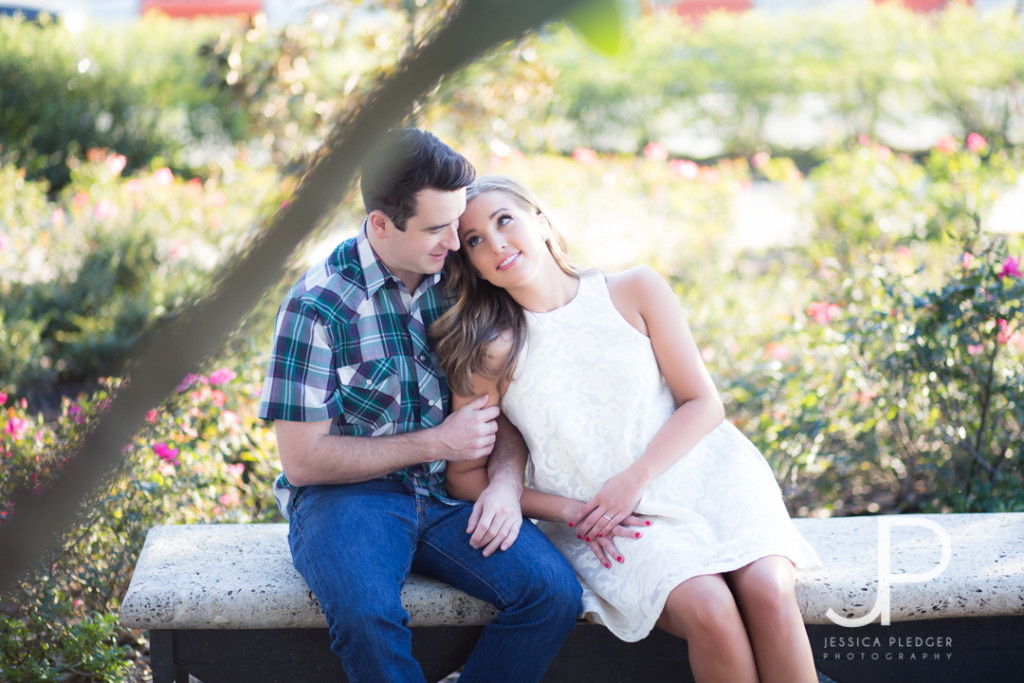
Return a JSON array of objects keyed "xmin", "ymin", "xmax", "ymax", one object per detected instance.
[{"xmin": 432, "ymin": 176, "xmax": 818, "ymax": 683}]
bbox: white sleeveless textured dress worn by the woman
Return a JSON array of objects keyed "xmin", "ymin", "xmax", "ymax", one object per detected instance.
[{"xmin": 501, "ymin": 271, "xmax": 820, "ymax": 641}]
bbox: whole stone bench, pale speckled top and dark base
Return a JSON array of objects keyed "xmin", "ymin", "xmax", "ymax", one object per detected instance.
[{"xmin": 121, "ymin": 513, "xmax": 1024, "ymax": 683}]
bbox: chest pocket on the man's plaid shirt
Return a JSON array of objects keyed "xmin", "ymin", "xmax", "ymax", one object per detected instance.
[{"xmin": 338, "ymin": 357, "xmax": 401, "ymax": 433}]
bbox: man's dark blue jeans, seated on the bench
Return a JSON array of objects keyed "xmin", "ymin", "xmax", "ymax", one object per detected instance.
[{"xmin": 289, "ymin": 479, "xmax": 581, "ymax": 683}]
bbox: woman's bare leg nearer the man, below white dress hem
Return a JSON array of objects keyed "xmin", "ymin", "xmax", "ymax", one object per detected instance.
[{"xmin": 657, "ymin": 574, "xmax": 758, "ymax": 683}]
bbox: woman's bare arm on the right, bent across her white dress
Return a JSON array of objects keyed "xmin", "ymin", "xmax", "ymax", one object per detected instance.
[{"xmin": 573, "ymin": 266, "xmax": 725, "ymax": 533}]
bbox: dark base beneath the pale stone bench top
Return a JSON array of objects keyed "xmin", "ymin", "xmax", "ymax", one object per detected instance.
[{"xmin": 150, "ymin": 614, "xmax": 1024, "ymax": 683}]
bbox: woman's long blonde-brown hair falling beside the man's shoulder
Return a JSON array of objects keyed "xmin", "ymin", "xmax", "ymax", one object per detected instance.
[{"xmin": 430, "ymin": 175, "xmax": 580, "ymax": 396}]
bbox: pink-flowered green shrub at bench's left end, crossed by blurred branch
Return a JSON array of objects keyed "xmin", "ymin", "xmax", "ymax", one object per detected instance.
[{"xmin": 0, "ymin": 357, "xmax": 280, "ymax": 681}]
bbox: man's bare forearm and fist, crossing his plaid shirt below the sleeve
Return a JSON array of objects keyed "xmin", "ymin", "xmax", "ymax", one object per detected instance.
[{"xmin": 274, "ymin": 397, "xmax": 501, "ymax": 489}]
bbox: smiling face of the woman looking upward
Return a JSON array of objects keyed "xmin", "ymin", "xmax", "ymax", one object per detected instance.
[{"xmin": 459, "ymin": 189, "xmax": 554, "ymax": 289}]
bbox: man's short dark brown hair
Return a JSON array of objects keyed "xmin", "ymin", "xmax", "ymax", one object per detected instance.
[{"xmin": 359, "ymin": 128, "xmax": 476, "ymax": 230}]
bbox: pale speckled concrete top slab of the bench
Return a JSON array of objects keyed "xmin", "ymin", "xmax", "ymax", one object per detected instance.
[{"xmin": 121, "ymin": 513, "xmax": 1024, "ymax": 630}]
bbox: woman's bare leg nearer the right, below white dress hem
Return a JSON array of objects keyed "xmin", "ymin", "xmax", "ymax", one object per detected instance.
[{"xmin": 726, "ymin": 555, "xmax": 818, "ymax": 683}]
